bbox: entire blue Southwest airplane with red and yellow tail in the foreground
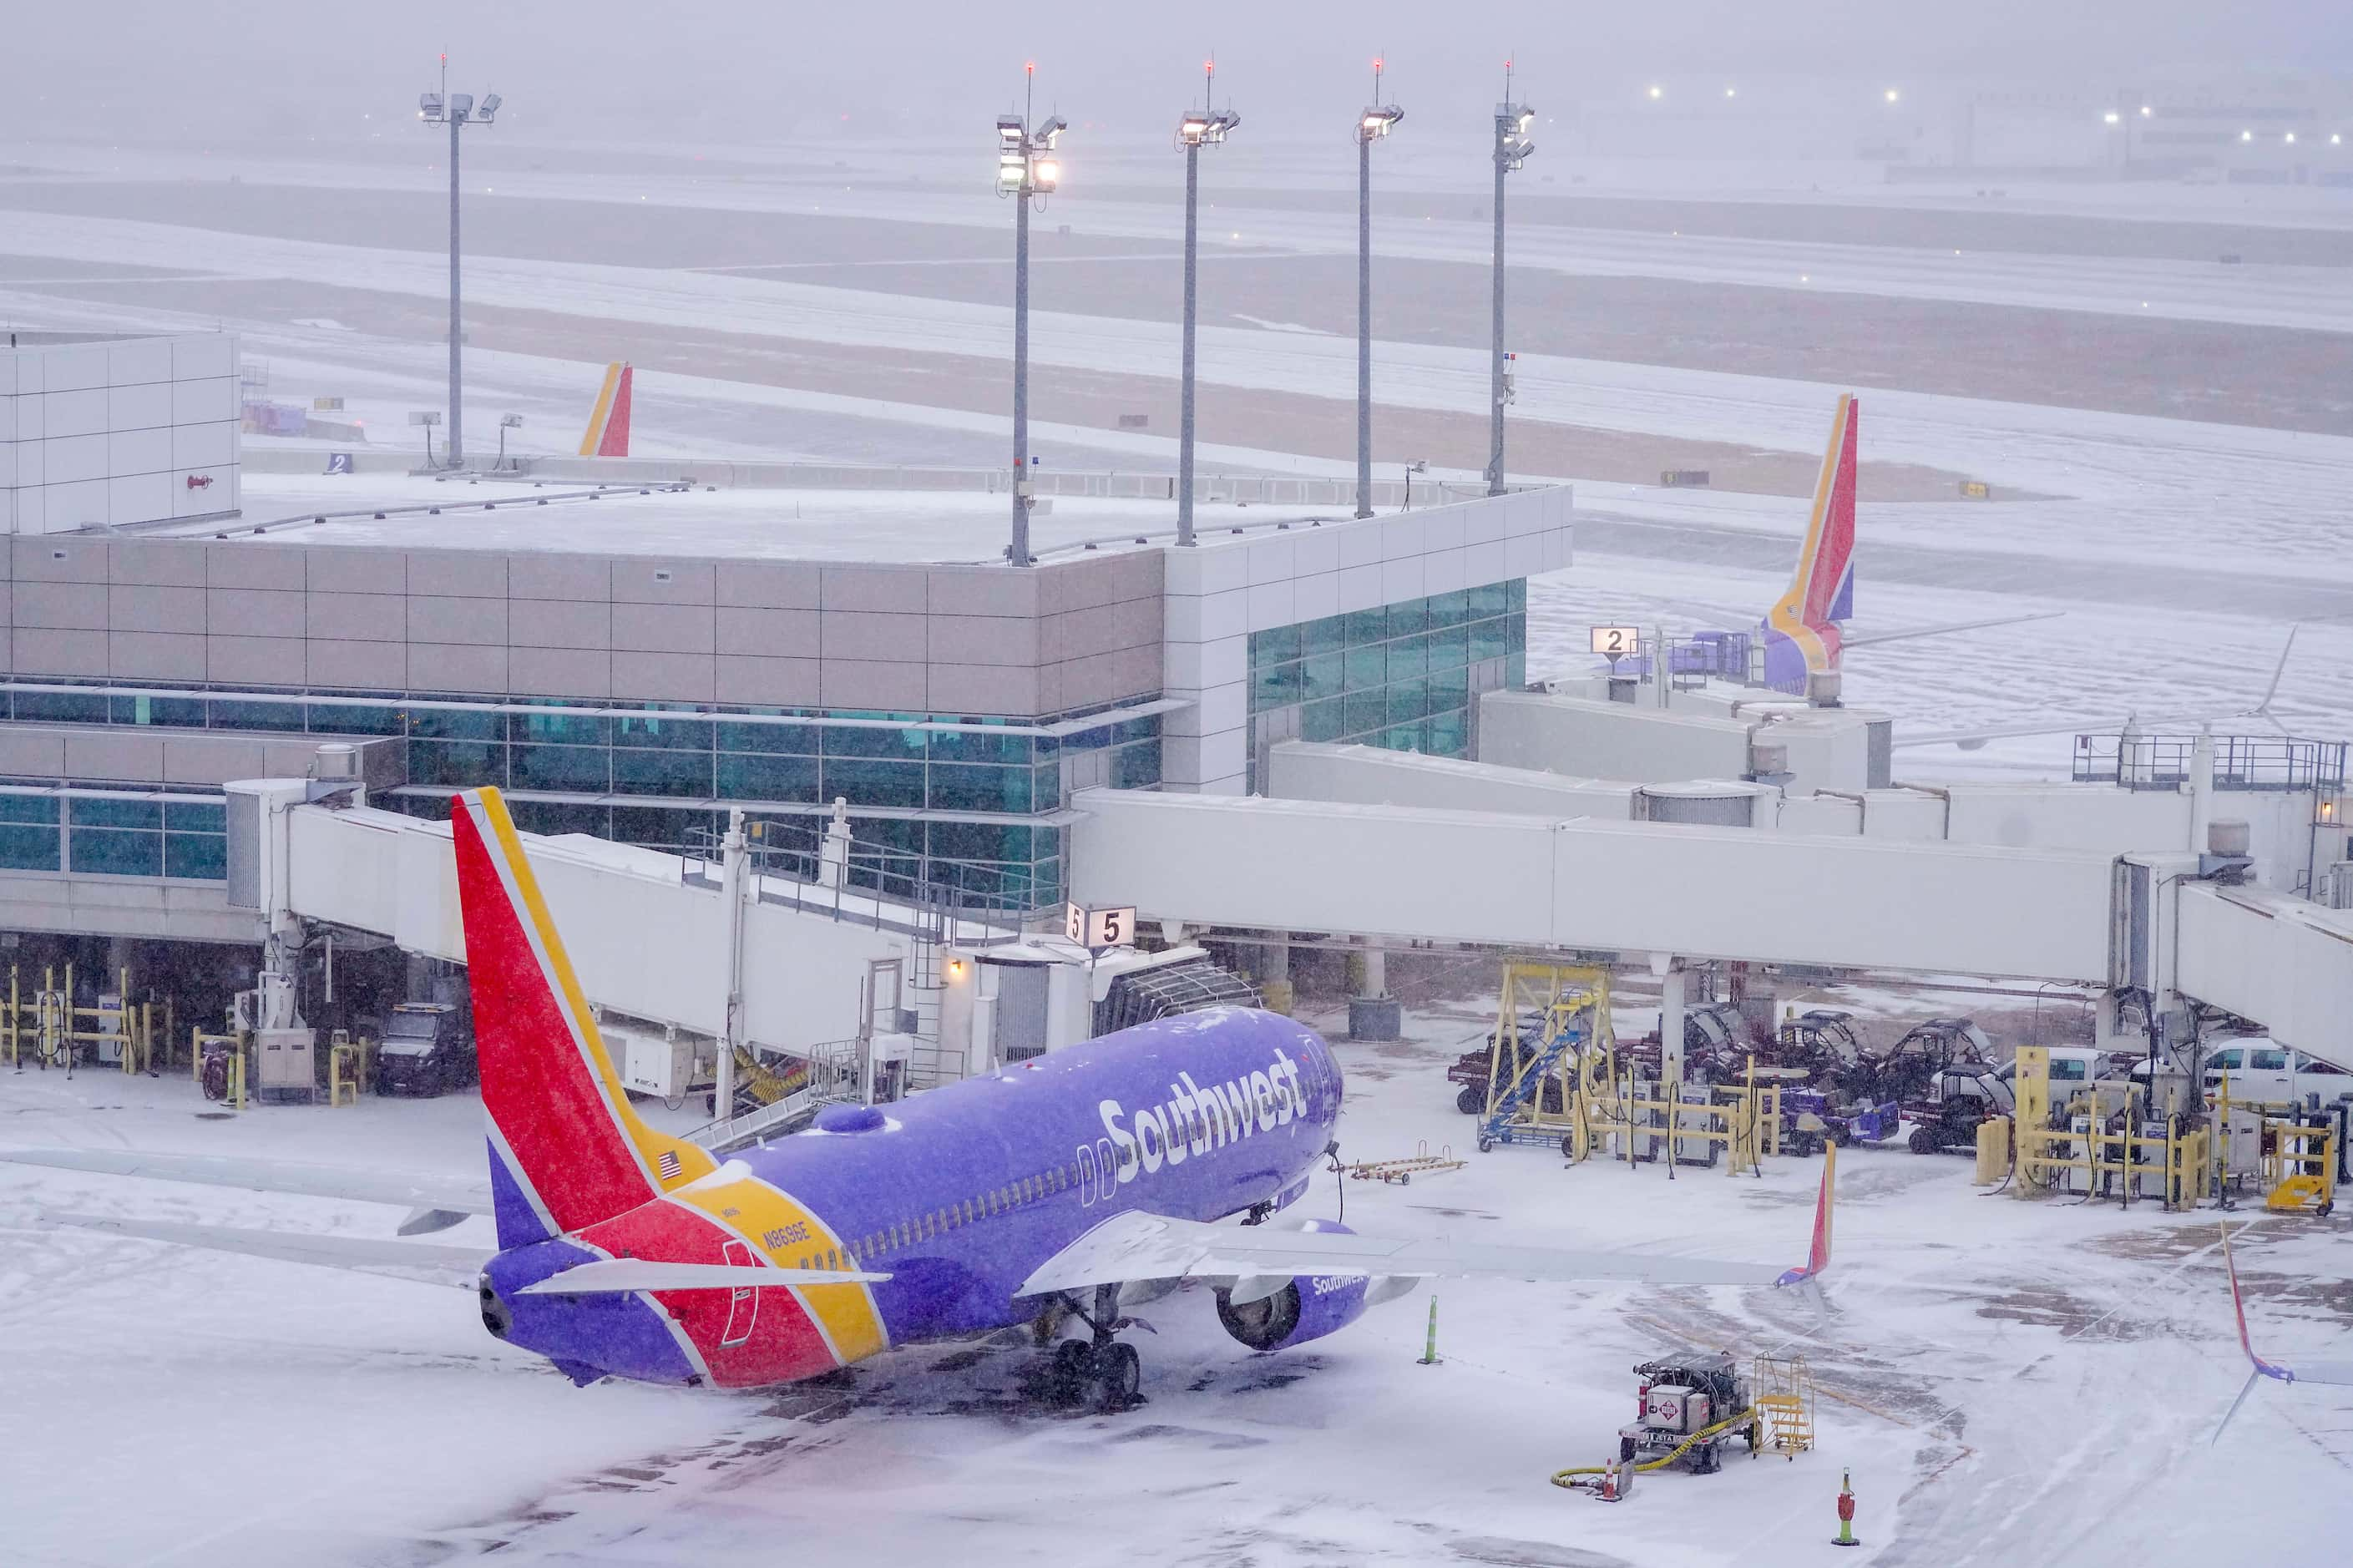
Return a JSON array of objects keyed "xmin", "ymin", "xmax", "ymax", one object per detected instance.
[{"xmin": 0, "ymin": 789, "xmax": 1830, "ymax": 1408}]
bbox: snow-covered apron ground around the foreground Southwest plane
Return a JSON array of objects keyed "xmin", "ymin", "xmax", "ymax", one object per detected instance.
[{"xmin": 0, "ymin": 999, "xmax": 2353, "ymax": 1568}]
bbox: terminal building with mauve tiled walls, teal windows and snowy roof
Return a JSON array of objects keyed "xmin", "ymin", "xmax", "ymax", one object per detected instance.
[{"xmin": 0, "ymin": 414, "xmax": 1570, "ymax": 918}]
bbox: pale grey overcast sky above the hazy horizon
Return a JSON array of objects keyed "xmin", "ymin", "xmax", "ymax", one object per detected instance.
[{"xmin": 0, "ymin": 0, "xmax": 2353, "ymax": 141}]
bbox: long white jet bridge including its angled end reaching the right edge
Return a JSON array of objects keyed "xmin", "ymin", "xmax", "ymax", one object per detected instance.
[{"xmin": 1070, "ymin": 789, "xmax": 2353, "ymax": 1055}]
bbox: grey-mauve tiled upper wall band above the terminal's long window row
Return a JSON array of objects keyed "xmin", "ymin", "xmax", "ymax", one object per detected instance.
[{"xmin": 0, "ymin": 537, "xmax": 1162, "ymax": 718}]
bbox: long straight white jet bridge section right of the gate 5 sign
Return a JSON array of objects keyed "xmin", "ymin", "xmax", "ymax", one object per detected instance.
[{"xmin": 1070, "ymin": 789, "xmax": 2113, "ymax": 984}]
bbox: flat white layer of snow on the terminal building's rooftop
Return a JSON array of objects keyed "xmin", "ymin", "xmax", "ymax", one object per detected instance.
[{"xmin": 222, "ymin": 473, "xmax": 1346, "ymax": 563}]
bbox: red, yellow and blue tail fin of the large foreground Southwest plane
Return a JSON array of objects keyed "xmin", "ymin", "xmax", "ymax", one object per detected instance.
[{"xmin": 449, "ymin": 789, "xmax": 713, "ymax": 1248}]
